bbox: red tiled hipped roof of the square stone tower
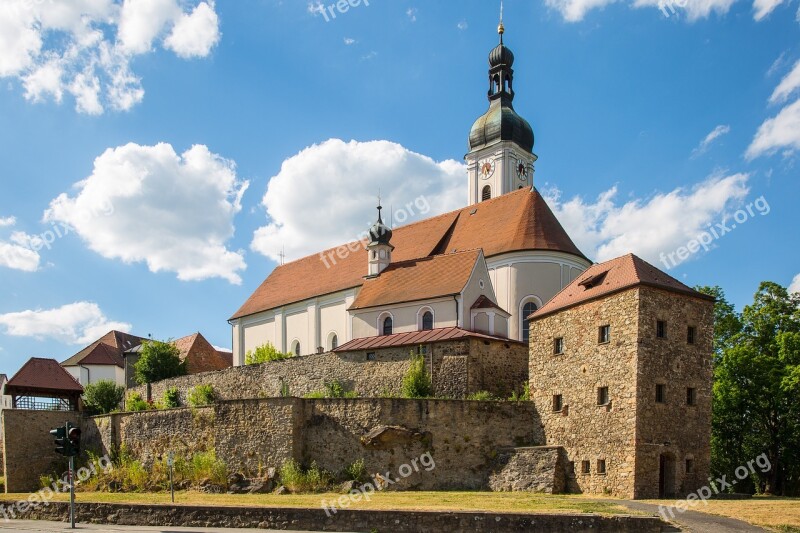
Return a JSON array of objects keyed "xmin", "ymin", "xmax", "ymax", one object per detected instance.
[{"xmin": 530, "ymin": 254, "xmax": 714, "ymax": 320}]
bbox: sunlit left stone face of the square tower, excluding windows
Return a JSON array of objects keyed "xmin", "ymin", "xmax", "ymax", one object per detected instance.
[{"xmin": 530, "ymin": 289, "xmax": 639, "ymax": 497}]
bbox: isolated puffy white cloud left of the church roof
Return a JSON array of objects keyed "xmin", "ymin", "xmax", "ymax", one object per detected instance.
[{"xmin": 44, "ymin": 143, "xmax": 248, "ymax": 284}]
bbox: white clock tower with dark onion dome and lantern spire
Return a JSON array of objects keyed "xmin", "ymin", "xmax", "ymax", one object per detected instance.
[{"xmin": 465, "ymin": 20, "xmax": 538, "ymax": 205}]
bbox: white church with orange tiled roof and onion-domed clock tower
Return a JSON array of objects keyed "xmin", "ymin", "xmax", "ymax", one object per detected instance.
[{"xmin": 230, "ymin": 20, "xmax": 592, "ymax": 365}]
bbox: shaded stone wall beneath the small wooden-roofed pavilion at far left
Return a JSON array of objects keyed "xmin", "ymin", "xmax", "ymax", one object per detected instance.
[{"xmin": 1, "ymin": 409, "xmax": 81, "ymax": 492}]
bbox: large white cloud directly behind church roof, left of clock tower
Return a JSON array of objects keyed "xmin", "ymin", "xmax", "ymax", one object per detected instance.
[{"xmin": 251, "ymin": 139, "xmax": 467, "ymax": 261}]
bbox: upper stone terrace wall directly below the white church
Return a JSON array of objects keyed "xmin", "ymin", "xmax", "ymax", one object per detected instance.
[{"xmin": 131, "ymin": 339, "xmax": 527, "ymax": 405}]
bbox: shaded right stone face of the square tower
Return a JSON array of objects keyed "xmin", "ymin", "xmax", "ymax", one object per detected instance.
[{"xmin": 634, "ymin": 287, "xmax": 714, "ymax": 498}]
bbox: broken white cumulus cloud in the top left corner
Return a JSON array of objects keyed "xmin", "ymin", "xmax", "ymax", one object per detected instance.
[{"xmin": 0, "ymin": 0, "xmax": 220, "ymax": 115}]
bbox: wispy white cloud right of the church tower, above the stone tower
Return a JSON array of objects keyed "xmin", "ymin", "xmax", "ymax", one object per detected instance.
[{"xmin": 543, "ymin": 174, "xmax": 749, "ymax": 264}]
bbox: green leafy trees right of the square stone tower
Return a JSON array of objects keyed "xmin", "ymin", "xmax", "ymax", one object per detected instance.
[{"xmin": 711, "ymin": 282, "xmax": 800, "ymax": 495}]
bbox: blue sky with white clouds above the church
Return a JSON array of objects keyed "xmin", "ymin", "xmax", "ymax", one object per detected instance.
[{"xmin": 0, "ymin": 0, "xmax": 800, "ymax": 375}]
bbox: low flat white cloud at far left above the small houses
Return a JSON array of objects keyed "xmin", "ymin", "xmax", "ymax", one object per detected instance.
[{"xmin": 0, "ymin": 302, "xmax": 131, "ymax": 344}]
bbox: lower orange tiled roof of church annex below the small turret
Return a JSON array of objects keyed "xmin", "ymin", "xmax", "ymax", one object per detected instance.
[{"xmin": 350, "ymin": 250, "xmax": 481, "ymax": 309}]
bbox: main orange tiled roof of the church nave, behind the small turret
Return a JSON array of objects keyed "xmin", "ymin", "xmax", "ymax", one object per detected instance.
[{"xmin": 232, "ymin": 189, "xmax": 586, "ymax": 319}]
